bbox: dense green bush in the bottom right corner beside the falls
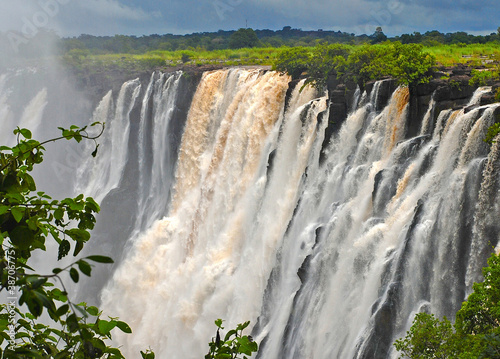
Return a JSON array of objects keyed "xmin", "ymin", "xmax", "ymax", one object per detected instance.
[{"xmin": 394, "ymin": 253, "xmax": 500, "ymax": 359}]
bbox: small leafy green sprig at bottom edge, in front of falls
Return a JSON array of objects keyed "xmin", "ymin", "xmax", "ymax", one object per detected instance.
[{"xmin": 205, "ymin": 319, "xmax": 258, "ymax": 359}]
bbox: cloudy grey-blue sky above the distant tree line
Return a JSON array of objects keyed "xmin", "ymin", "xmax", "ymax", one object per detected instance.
[{"xmin": 0, "ymin": 0, "xmax": 500, "ymax": 37}]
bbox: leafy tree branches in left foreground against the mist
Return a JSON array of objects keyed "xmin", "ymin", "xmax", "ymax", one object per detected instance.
[{"xmin": 0, "ymin": 123, "xmax": 141, "ymax": 359}]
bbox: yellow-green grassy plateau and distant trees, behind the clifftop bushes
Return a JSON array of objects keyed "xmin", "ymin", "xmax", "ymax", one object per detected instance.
[{"xmin": 0, "ymin": 26, "xmax": 500, "ymax": 72}]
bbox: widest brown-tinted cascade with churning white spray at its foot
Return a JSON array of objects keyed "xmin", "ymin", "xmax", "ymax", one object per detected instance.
[{"xmin": 98, "ymin": 70, "xmax": 326, "ymax": 358}]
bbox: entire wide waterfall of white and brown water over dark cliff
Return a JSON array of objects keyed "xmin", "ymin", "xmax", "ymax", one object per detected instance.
[{"xmin": 0, "ymin": 64, "xmax": 500, "ymax": 359}]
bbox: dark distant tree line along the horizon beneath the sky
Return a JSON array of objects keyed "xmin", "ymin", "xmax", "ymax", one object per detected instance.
[{"xmin": 49, "ymin": 26, "xmax": 500, "ymax": 54}]
